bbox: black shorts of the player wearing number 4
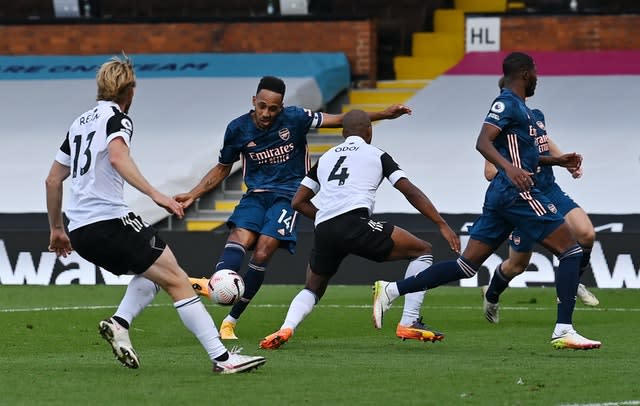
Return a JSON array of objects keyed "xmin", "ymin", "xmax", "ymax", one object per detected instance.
[{"xmin": 309, "ymin": 209, "xmax": 394, "ymax": 275}]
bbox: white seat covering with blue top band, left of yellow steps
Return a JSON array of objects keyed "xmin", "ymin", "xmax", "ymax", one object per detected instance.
[{"xmin": 0, "ymin": 53, "xmax": 350, "ymax": 230}]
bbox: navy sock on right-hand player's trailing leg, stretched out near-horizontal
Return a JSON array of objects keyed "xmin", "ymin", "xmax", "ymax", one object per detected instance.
[{"xmin": 397, "ymin": 257, "xmax": 477, "ymax": 295}]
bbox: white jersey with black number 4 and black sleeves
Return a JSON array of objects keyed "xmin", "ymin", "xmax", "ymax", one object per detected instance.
[{"xmin": 302, "ymin": 136, "xmax": 407, "ymax": 225}]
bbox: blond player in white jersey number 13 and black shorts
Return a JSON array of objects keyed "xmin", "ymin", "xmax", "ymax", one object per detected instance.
[{"xmin": 45, "ymin": 55, "xmax": 266, "ymax": 374}]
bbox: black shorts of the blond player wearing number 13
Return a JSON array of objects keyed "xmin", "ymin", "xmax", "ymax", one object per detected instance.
[{"xmin": 69, "ymin": 213, "xmax": 167, "ymax": 275}]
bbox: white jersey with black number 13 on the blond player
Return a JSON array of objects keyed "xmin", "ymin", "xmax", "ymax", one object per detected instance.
[{"xmin": 56, "ymin": 101, "xmax": 133, "ymax": 231}]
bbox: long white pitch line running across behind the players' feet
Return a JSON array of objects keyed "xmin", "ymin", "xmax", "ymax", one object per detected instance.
[{"xmin": 0, "ymin": 303, "xmax": 640, "ymax": 313}]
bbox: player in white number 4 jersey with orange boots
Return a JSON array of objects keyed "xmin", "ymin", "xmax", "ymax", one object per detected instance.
[{"xmin": 260, "ymin": 110, "xmax": 460, "ymax": 350}]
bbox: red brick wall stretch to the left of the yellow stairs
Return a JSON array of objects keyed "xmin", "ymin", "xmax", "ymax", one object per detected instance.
[{"xmin": 0, "ymin": 19, "xmax": 378, "ymax": 81}]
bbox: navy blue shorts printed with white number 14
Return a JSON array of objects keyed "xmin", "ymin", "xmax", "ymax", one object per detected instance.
[{"xmin": 227, "ymin": 192, "xmax": 298, "ymax": 254}]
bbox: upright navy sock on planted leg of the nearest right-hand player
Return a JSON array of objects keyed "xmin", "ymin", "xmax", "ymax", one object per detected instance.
[{"xmin": 556, "ymin": 245, "xmax": 582, "ymax": 324}]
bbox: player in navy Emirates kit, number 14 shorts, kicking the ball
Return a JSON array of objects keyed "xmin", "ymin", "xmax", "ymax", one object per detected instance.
[{"xmin": 176, "ymin": 76, "xmax": 411, "ymax": 340}]
